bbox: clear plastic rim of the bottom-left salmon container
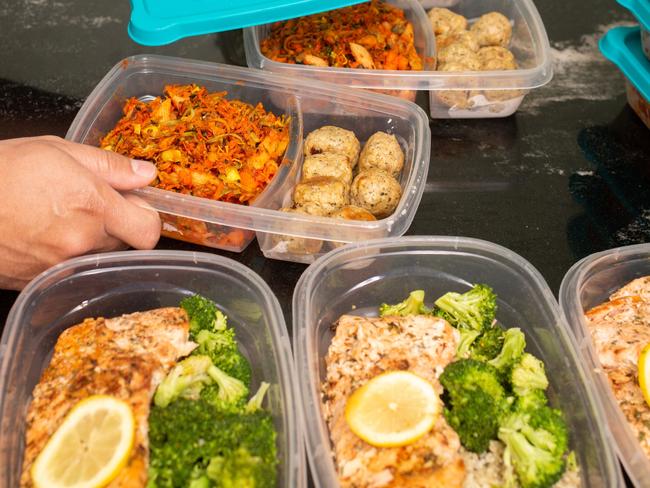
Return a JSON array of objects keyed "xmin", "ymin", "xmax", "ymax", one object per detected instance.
[{"xmin": 0, "ymin": 250, "xmax": 307, "ymax": 487}]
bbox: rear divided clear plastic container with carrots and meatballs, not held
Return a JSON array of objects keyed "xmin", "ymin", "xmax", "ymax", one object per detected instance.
[{"xmin": 244, "ymin": 0, "xmax": 553, "ymax": 118}]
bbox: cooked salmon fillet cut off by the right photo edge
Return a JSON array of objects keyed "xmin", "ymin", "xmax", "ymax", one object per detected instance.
[{"xmin": 585, "ymin": 276, "xmax": 650, "ymax": 457}]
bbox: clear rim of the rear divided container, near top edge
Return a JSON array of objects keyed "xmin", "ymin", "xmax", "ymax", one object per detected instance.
[{"xmin": 244, "ymin": 0, "xmax": 553, "ymax": 90}]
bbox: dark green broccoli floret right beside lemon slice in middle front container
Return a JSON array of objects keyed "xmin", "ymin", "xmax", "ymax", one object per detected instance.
[{"xmin": 440, "ymin": 359, "xmax": 509, "ymax": 452}]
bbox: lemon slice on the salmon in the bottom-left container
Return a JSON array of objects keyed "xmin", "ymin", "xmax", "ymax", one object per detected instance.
[{"xmin": 31, "ymin": 395, "xmax": 135, "ymax": 488}]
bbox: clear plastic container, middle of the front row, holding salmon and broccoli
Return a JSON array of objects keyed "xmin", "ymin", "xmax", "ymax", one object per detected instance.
[{"xmin": 293, "ymin": 236, "xmax": 624, "ymax": 488}]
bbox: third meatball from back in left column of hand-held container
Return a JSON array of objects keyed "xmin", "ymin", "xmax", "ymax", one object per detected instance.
[{"xmin": 293, "ymin": 176, "xmax": 349, "ymax": 216}]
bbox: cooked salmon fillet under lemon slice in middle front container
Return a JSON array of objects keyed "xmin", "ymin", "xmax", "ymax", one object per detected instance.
[{"xmin": 322, "ymin": 315, "xmax": 465, "ymax": 488}]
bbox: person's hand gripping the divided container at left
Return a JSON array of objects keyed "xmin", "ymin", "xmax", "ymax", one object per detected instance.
[{"xmin": 0, "ymin": 136, "xmax": 161, "ymax": 290}]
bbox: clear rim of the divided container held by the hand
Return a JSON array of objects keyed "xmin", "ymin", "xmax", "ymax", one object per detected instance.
[{"xmin": 65, "ymin": 54, "xmax": 431, "ymax": 241}]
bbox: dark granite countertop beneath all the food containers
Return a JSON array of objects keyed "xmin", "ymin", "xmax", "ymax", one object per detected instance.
[{"xmin": 0, "ymin": 0, "xmax": 650, "ymax": 482}]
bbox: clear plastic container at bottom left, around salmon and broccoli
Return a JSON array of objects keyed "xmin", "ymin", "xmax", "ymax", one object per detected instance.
[{"xmin": 0, "ymin": 251, "xmax": 307, "ymax": 488}]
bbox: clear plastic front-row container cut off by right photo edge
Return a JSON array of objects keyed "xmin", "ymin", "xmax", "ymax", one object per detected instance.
[{"xmin": 560, "ymin": 244, "xmax": 650, "ymax": 487}]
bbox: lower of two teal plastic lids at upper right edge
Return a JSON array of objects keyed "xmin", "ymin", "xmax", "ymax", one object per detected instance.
[{"xmin": 598, "ymin": 26, "xmax": 650, "ymax": 100}]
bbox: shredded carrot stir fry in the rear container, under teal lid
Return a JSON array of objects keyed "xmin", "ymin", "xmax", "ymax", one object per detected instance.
[{"xmin": 261, "ymin": 0, "xmax": 422, "ymax": 70}]
